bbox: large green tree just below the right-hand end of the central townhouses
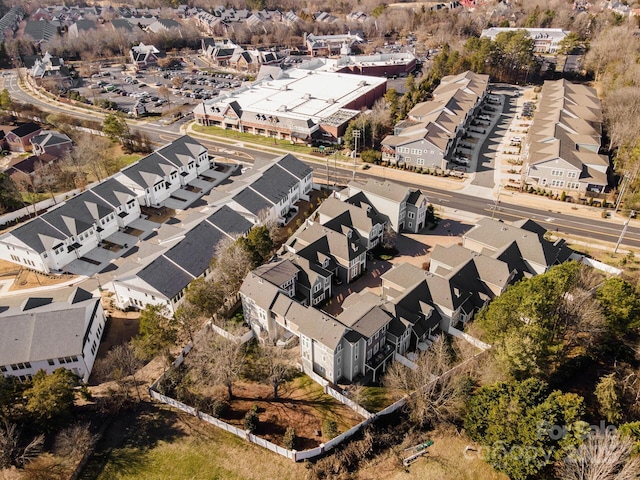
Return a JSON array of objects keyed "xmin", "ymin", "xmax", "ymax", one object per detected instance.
[{"xmin": 475, "ymin": 262, "xmax": 604, "ymax": 379}]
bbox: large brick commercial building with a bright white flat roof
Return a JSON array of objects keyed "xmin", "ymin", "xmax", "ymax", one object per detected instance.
[{"xmin": 193, "ymin": 62, "xmax": 387, "ymax": 143}]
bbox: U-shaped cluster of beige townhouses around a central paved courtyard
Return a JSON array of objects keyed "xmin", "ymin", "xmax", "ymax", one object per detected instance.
[{"xmin": 240, "ymin": 186, "xmax": 573, "ymax": 383}]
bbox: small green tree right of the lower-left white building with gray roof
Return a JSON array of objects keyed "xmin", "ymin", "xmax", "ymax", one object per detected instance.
[{"xmin": 131, "ymin": 305, "xmax": 176, "ymax": 361}]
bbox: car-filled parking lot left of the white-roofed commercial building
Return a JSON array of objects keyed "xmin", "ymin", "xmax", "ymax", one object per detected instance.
[{"xmin": 75, "ymin": 65, "xmax": 246, "ymax": 116}]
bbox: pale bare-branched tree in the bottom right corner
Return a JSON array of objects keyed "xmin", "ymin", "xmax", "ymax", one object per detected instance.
[{"xmin": 558, "ymin": 432, "xmax": 640, "ymax": 480}]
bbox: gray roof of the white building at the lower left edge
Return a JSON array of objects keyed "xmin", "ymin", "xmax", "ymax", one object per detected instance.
[{"xmin": 0, "ymin": 289, "xmax": 100, "ymax": 365}]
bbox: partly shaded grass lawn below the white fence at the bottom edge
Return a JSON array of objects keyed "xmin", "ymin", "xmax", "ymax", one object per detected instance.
[{"xmin": 86, "ymin": 404, "xmax": 305, "ymax": 480}]
